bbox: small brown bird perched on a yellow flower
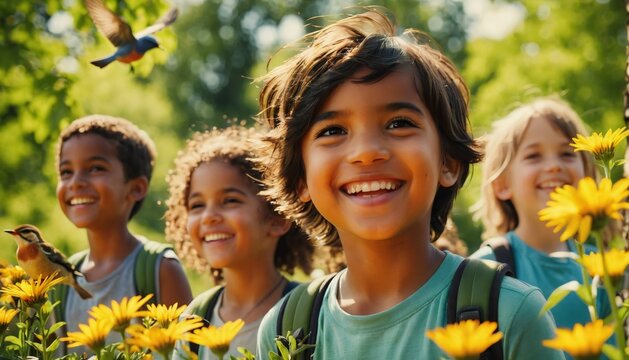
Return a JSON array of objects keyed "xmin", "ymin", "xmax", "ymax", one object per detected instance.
[{"xmin": 4, "ymin": 225, "xmax": 92, "ymax": 299}]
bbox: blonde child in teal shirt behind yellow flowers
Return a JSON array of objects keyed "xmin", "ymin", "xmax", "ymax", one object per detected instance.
[{"xmin": 470, "ymin": 97, "xmax": 608, "ymax": 334}]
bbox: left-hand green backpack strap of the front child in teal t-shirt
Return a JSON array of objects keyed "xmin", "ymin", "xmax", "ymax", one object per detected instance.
[{"xmin": 276, "ymin": 274, "xmax": 336, "ymax": 359}]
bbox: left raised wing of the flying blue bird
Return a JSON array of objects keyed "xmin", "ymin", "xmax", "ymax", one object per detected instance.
[{"xmin": 85, "ymin": 0, "xmax": 135, "ymax": 47}]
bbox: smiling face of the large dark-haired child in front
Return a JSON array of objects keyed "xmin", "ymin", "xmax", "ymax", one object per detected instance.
[{"xmin": 300, "ymin": 67, "xmax": 458, "ymax": 241}]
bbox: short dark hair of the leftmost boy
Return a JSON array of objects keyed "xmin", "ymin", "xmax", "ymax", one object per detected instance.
[{"xmin": 57, "ymin": 115, "xmax": 157, "ymax": 220}]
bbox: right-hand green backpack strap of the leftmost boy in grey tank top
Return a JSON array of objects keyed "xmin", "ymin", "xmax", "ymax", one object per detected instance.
[{"xmin": 133, "ymin": 238, "xmax": 172, "ymax": 304}]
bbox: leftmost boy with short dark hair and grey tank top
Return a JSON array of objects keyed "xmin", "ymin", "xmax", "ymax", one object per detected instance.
[{"xmin": 57, "ymin": 115, "xmax": 192, "ymax": 353}]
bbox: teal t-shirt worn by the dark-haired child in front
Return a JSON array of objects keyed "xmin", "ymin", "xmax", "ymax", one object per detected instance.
[{"xmin": 257, "ymin": 253, "xmax": 564, "ymax": 360}]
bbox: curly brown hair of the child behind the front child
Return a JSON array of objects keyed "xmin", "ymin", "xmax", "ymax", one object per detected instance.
[{"xmin": 165, "ymin": 126, "xmax": 314, "ymax": 283}]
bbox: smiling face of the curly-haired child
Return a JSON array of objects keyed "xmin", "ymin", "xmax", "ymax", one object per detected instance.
[{"xmin": 187, "ymin": 160, "xmax": 281, "ymax": 268}]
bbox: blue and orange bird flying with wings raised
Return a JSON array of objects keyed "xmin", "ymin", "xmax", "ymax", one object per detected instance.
[{"xmin": 85, "ymin": 0, "xmax": 179, "ymax": 69}]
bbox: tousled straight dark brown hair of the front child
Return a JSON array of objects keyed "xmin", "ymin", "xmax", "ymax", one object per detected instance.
[{"xmin": 259, "ymin": 9, "xmax": 481, "ymax": 245}]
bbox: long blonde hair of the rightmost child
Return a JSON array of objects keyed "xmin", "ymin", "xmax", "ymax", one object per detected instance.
[{"xmin": 475, "ymin": 97, "xmax": 597, "ymax": 238}]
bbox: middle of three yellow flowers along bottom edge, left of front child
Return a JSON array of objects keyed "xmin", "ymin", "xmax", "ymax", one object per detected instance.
[{"xmin": 127, "ymin": 318, "xmax": 203, "ymax": 355}]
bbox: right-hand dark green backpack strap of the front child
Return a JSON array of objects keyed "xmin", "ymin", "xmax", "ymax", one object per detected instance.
[{"xmin": 446, "ymin": 259, "xmax": 511, "ymax": 360}]
